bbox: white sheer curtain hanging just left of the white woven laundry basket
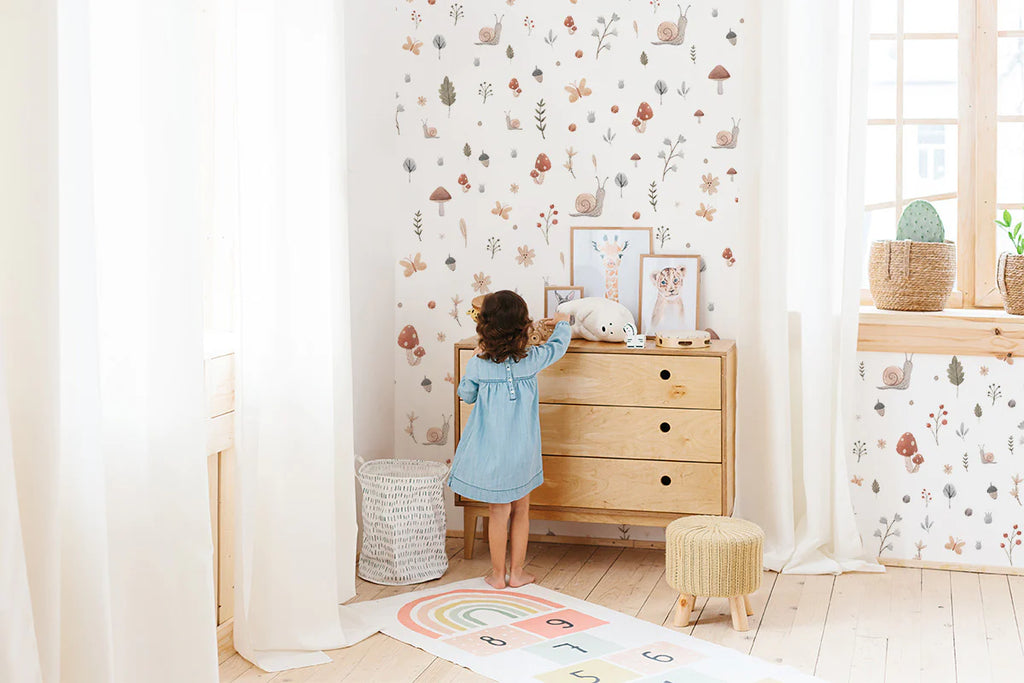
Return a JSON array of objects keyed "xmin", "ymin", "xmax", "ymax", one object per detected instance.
[{"xmin": 215, "ymin": 0, "xmax": 369, "ymax": 671}]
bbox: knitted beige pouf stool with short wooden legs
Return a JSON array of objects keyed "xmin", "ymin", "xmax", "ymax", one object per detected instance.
[{"xmin": 665, "ymin": 516, "xmax": 765, "ymax": 631}]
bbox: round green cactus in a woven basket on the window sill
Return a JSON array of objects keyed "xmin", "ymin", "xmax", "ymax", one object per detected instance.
[{"xmin": 868, "ymin": 201, "xmax": 956, "ymax": 310}]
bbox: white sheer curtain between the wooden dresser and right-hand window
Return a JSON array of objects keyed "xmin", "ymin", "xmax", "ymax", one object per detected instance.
[{"xmin": 736, "ymin": 0, "xmax": 882, "ymax": 573}]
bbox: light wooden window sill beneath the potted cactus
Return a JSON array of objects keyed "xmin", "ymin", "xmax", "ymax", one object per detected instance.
[{"xmin": 857, "ymin": 306, "xmax": 1024, "ymax": 359}]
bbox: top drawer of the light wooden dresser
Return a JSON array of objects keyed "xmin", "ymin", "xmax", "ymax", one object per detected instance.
[{"xmin": 538, "ymin": 353, "xmax": 722, "ymax": 410}]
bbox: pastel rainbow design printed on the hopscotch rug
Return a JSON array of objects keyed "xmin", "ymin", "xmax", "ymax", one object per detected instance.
[{"xmin": 398, "ymin": 589, "xmax": 563, "ymax": 638}]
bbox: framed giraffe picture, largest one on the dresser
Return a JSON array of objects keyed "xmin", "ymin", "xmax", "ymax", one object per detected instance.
[{"xmin": 569, "ymin": 226, "xmax": 654, "ymax": 319}]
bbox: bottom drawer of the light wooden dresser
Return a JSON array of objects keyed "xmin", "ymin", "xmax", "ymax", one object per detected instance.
[{"xmin": 530, "ymin": 456, "xmax": 722, "ymax": 515}]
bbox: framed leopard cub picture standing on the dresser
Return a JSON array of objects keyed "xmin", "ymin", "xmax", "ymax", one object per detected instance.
[{"xmin": 637, "ymin": 254, "xmax": 700, "ymax": 337}]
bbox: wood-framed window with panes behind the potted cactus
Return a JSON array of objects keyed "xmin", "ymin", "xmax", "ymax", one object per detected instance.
[{"xmin": 863, "ymin": 0, "xmax": 1024, "ymax": 306}]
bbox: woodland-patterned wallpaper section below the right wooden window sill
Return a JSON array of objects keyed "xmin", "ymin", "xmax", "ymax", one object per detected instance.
[{"xmin": 848, "ymin": 353, "xmax": 1024, "ymax": 567}]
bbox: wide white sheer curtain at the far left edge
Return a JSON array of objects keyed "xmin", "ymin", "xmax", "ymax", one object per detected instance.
[{"xmin": 0, "ymin": 0, "xmax": 217, "ymax": 683}]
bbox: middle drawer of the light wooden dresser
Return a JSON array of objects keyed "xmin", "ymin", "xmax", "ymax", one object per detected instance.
[{"xmin": 459, "ymin": 403, "xmax": 722, "ymax": 463}]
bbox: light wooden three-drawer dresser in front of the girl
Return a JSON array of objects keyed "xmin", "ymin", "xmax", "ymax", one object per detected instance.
[{"xmin": 455, "ymin": 338, "xmax": 736, "ymax": 558}]
